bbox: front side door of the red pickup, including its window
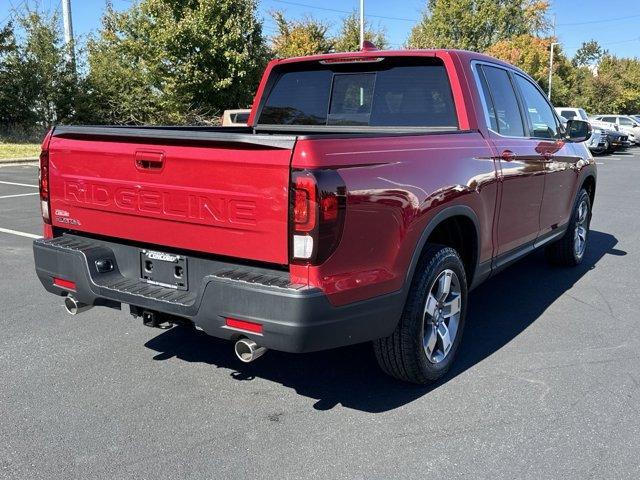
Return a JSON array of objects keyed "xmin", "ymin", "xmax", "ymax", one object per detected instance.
[{"xmin": 513, "ymin": 73, "xmax": 587, "ymax": 235}]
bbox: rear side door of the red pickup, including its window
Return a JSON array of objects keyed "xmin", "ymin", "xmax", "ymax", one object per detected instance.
[{"xmin": 475, "ymin": 63, "xmax": 545, "ymax": 257}]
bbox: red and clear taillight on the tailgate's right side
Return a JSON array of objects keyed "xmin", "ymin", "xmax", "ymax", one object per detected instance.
[{"xmin": 290, "ymin": 170, "xmax": 346, "ymax": 265}]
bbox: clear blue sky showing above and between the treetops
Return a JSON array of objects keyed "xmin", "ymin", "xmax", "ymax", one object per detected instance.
[{"xmin": 0, "ymin": 0, "xmax": 640, "ymax": 57}]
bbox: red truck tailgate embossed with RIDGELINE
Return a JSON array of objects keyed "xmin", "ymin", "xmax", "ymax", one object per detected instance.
[{"xmin": 49, "ymin": 127, "xmax": 294, "ymax": 264}]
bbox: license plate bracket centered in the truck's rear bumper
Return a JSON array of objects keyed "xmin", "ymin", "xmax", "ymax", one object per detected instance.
[{"xmin": 140, "ymin": 250, "xmax": 189, "ymax": 290}]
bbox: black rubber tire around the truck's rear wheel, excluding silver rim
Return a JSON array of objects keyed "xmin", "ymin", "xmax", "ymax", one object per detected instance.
[{"xmin": 373, "ymin": 244, "xmax": 467, "ymax": 385}]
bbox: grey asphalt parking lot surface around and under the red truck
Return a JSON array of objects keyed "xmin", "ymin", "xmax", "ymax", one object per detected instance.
[{"xmin": 0, "ymin": 148, "xmax": 640, "ymax": 479}]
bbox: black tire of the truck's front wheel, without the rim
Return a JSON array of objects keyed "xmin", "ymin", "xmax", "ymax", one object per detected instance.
[{"xmin": 545, "ymin": 188, "xmax": 591, "ymax": 267}]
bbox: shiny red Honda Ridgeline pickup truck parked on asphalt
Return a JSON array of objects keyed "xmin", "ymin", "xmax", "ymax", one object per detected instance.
[{"xmin": 34, "ymin": 49, "xmax": 596, "ymax": 383}]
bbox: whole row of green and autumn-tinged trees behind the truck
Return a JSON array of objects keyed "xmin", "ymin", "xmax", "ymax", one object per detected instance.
[{"xmin": 0, "ymin": 0, "xmax": 640, "ymax": 133}]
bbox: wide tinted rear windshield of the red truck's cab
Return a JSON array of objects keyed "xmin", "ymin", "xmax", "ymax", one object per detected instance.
[{"xmin": 258, "ymin": 58, "xmax": 458, "ymax": 129}]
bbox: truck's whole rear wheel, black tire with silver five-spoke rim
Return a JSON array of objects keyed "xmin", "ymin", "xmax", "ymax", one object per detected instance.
[{"xmin": 374, "ymin": 245, "xmax": 467, "ymax": 384}]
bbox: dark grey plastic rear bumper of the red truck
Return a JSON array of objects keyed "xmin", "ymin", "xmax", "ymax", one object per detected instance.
[{"xmin": 33, "ymin": 235, "xmax": 404, "ymax": 352}]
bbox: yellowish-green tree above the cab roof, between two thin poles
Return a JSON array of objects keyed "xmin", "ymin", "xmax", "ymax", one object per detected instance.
[{"xmin": 408, "ymin": 0, "xmax": 549, "ymax": 52}]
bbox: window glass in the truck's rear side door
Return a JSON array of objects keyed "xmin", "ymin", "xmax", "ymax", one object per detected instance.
[{"xmin": 479, "ymin": 65, "xmax": 524, "ymax": 137}]
